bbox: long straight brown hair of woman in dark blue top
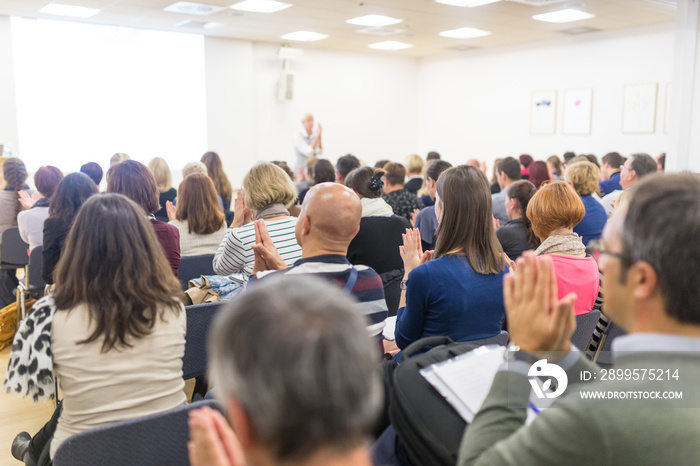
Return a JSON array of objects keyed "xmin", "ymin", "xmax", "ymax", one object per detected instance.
[{"xmin": 435, "ymin": 165, "xmax": 505, "ymax": 274}]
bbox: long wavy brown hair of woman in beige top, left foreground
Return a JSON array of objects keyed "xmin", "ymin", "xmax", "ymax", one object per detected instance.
[{"xmin": 54, "ymin": 194, "xmax": 180, "ymax": 352}]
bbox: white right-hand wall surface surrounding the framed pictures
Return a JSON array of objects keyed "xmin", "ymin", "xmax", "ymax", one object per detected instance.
[{"xmin": 417, "ymin": 23, "xmax": 674, "ymax": 168}]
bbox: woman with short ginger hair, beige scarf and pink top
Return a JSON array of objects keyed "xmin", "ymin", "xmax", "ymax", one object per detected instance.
[{"xmin": 526, "ymin": 180, "xmax": 600, "ymax": 315}]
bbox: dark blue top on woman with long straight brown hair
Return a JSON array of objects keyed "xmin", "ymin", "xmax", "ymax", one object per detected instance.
[{"xmin": 395, "ymin": 255, "xmax": 508, "ymax": 349}]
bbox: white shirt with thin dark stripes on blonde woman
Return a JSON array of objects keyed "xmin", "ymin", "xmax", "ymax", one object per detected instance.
[{"xmin": 213, "ymin": 217, "xmax": 301, "ymax": 279}]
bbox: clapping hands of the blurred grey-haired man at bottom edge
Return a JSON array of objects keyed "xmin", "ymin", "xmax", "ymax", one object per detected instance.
[{"xmin": 187, "ymin": 407, "xmax": 246, "ymax": 466}]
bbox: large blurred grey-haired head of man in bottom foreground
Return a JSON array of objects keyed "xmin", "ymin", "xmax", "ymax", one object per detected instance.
[{"xmin": 209, "ymin": 275, "xmax": 382, "ymax": 464}]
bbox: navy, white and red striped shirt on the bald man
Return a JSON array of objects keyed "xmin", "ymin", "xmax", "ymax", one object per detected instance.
[{"xmin": 251, "ymin": 254, "xmax": 389, "ymax": 337}]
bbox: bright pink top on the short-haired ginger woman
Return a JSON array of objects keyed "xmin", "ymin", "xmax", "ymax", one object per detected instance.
[{"xmin": 549, "ymin": 254, "xmax": 600, "ymax": 316}]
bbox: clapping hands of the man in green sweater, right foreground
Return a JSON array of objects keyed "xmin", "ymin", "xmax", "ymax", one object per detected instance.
[{"xmin": 503, "ymin": 251, "xmax": 576, "ymax": 352}]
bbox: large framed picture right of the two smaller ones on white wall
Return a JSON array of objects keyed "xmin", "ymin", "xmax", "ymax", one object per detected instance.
[{"xmin": 622, "ymin": 83, "xmax": 658, "ymax": 134}]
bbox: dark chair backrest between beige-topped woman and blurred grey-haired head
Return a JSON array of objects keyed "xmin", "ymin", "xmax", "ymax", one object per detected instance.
[{"xmin": 182, "ymin": 301, "xmax": 228, "ymax": 380}]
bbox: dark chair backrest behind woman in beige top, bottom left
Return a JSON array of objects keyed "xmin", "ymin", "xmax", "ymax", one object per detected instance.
[{"xmin": 53, "ymin": 400, "xmax": 220, "ymax": 466}]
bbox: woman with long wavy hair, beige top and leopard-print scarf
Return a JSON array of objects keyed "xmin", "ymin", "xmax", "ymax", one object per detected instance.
[{"xmin": 5, "ymin": 194, "xmax": 187, "ymax": 465}]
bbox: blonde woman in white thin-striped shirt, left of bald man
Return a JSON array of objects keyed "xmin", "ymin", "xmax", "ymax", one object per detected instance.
[{"xmin": 213, "ymin": 163, "xmax": 300, "ymax": 281}]
